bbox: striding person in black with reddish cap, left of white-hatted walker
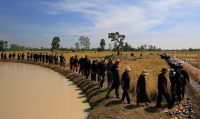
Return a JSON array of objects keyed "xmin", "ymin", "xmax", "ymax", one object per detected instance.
[{"xmin": 106, "ymin": 59, "xmax": 121, "ymax": 98}]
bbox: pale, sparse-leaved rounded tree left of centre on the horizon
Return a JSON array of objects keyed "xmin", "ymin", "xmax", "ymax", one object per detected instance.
[{"xmin": 79, "ymin": 36, "xmax": 90, "ymax": 51}]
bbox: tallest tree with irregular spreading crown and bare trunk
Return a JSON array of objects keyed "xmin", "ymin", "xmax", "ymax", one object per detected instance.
[{"xmin": 108, "ymin": 32, "xmax": 125, "ymax": 55}]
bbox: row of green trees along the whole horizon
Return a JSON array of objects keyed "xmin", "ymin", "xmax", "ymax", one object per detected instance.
[{"xmin": 0, "ymin": 32, "xmax": 200, "ymax": 52}]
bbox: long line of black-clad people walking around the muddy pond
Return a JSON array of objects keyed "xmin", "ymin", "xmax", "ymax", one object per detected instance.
[{"xmin": 1, "ymin": 52, "xmax": 190, "ymax": 108}]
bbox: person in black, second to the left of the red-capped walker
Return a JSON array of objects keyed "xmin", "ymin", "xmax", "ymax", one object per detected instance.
[{"xmin": 98, "ymin": 58, "xmax": 106, "ymax": 88}]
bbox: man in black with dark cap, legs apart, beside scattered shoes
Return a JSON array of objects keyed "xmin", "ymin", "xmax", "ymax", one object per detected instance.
[{"xmin": 156, "ymin": 68, "xmax": 172, "ymax": 109}]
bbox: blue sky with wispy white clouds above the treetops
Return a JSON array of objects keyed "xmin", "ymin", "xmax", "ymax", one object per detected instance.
[{"xmin": 0, "ymin": 0, "xmax": 200, "ymax": 49}]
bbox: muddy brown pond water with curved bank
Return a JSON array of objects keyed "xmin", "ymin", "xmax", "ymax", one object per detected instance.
[{"xmin": 0, "ymin": 62, "xmax": 90, "ymax": 119}]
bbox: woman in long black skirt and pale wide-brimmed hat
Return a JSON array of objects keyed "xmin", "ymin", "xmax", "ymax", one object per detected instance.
[{"xmin": 137, "ymin": 70, "xmax": 151, "ymax": 106}]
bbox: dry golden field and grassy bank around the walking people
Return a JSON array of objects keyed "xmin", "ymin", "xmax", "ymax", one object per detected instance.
[{"xmin": 1, "ymin": 52, "xmax": 200, "ymax": 119}]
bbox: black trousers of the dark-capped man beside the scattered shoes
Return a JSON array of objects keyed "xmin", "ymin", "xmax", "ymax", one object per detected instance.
[{"xmin": 156, "ymin": 92, "xmax": 172, "ymax": 108}]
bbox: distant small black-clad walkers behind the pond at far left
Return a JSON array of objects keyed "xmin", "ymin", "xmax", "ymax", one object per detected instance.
[{"xmin": 1, "ymin": 52, "xmax": 66, "ymax": 67}]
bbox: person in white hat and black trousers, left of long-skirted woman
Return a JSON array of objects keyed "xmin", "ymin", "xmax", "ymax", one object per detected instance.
[{"xmin": 121, "ymin": 66, "xmax": 132, "ymax": 104}]
